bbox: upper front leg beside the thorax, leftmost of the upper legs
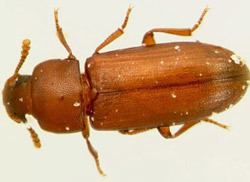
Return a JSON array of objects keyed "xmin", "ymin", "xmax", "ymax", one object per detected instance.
[{"xmin": 54, "ymin": 9, "xmax": 75, "ymax": 59}]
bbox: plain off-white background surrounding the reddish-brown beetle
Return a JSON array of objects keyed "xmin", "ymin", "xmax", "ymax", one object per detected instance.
[{"xmin": 0, "ymin": 0, "xmax": 250, "ymax": 182}]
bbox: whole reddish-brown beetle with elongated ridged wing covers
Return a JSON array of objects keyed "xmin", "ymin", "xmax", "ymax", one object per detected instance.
[{"xmin": 3, "ymin": 7, "xmax": 250, "ymax": 175}]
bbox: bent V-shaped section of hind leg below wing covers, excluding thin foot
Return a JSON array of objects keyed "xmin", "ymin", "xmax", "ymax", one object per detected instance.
[{"xmin": 158, "ymin": 121, "xmax": 200, "ymax": 138}]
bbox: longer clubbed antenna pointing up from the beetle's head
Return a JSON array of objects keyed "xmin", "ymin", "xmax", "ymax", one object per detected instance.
[{"xmin": 12, "ymin": 39, "xmax": 31, "ymax": 80}]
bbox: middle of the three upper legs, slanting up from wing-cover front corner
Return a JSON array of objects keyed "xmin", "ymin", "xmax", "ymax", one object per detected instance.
[{"xmin": 94, "ymin": 7, "xmax": 132, "ymax": 54}]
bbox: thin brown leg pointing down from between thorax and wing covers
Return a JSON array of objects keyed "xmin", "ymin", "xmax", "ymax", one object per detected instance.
[{"xmin": 82, "ymin": 116, "xmax": 105, "ymax": 176}]
